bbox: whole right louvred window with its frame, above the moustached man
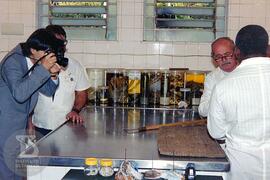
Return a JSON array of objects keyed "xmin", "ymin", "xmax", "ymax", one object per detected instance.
[{"xmin": 144, "ymin": 0, "xmax": 227, "ymax": 42}]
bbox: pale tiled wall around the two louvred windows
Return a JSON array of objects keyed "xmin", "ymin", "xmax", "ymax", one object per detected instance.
[{"xmin": 0, "ymin": 0, "xmax": 270, "ymax": 70}]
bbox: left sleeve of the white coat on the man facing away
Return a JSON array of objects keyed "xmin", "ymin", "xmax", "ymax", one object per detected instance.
[{"xmin": 207, "ymin": 84, "xmax": 227, "ymax": 139}]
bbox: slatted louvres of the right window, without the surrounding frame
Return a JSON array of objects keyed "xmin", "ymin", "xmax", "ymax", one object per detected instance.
[{"xmin": 156, "ymin": 0, "xmax": 216, "ymax": 31}]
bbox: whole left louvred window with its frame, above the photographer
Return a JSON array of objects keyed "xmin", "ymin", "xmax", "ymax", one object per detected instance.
[{"xmin": 39, "ymin": 0, "xmax": 117, "ymax": 40}]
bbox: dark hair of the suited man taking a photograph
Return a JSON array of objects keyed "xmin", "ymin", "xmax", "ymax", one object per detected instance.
[{"xmin": 21, "ymin": 28, "xmax": 64, "ymax": 56}]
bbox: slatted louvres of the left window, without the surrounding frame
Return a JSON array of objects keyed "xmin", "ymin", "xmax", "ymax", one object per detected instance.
[{"xmin": 49, "ymin": 0, "xmax": 108, "ymax": 28}]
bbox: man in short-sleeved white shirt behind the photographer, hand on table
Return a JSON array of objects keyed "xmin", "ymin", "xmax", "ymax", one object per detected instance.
[{"xmin": 32, "ymin": 25, "xmax": 90, "ymax": 139}]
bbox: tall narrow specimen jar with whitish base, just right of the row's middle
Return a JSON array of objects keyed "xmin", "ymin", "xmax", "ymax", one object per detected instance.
[{"xmin": 160, "ymin": 71, "xmax": 170, "ymax": 106}]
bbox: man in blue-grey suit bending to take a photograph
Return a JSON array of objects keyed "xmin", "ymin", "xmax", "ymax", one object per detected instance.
[{"xmin": 0, "ymin": 29, "xmax": 63, "ymax": 180}]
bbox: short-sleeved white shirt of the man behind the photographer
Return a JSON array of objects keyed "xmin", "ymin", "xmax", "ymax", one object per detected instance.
[{"xmin": 32, "ymin": 59, "xmax": 90, "ymax": 130}]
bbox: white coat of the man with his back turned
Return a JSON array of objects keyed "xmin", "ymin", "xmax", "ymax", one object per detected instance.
[{"xmin": 207, "ymin": 57, "xmax": 270, "ymax": 180}]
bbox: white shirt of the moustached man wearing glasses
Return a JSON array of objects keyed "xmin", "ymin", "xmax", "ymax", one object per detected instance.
[{"xmin": 198, "ymin": 67, "xmax": 229, "ymax": 117}]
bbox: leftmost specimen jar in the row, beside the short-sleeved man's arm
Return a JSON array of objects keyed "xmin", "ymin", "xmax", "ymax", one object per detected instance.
[{"xmin": 86, "ymin": 68, "xmax": 105, "ymax": 103}]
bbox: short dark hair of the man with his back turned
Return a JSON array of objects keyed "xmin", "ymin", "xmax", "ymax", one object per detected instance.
[{"xmin": 235, "ymin": 25, "xmax": 269, "ymax": 57}]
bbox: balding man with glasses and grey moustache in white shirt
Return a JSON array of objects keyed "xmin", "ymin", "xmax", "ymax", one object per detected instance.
[{"xmin": 199, "ymin": 37, "xmax": 238, "ymax": 117}]
